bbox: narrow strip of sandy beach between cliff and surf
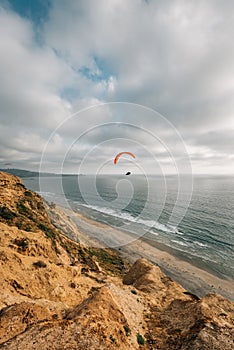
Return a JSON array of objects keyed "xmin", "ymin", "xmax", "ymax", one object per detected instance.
[{"xmin": 46, "ymin": 204, "xmax": 234, "ymax": 301}]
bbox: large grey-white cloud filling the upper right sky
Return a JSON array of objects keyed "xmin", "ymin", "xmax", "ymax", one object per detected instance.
[{"xmin": 45, "ymin": 1, "xmax": 234, "ymax": 128}]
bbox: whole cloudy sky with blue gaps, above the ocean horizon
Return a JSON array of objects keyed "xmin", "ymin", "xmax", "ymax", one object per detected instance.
[{"xmin": 0, "ymin": 0, "xmax": 234, "ymax": 175}]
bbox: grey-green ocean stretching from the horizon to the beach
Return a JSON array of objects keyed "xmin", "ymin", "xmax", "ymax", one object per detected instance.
[{"xmin": 23, "ymin": 175, "xmax": 234, "ymax": 280}]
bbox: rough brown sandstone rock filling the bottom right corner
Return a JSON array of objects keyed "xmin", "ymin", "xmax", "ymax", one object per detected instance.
[{"xmin": 147, "ymin": 295, "xmax": 234, "ymax": 350}]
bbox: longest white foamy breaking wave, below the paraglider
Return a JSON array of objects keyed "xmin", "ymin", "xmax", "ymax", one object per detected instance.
[{"xmin": 79, "ymin": 203, "xmax": 179, "ymax": 233}]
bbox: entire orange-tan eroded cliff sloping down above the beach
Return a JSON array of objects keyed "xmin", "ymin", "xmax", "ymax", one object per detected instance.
[{"xmin": 0, "ymin": 173, "xmax": 234, "ymax": 350}]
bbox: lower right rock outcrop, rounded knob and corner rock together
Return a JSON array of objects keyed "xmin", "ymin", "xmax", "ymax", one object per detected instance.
[{"xmin": 123, "ymin": 259, "xmax": 234, "ymax": 350}]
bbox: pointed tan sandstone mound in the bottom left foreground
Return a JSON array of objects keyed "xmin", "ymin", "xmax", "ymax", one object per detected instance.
[{"xmin": 2, "ymin": 287, "xmax": 133, "ymax": 350}]
